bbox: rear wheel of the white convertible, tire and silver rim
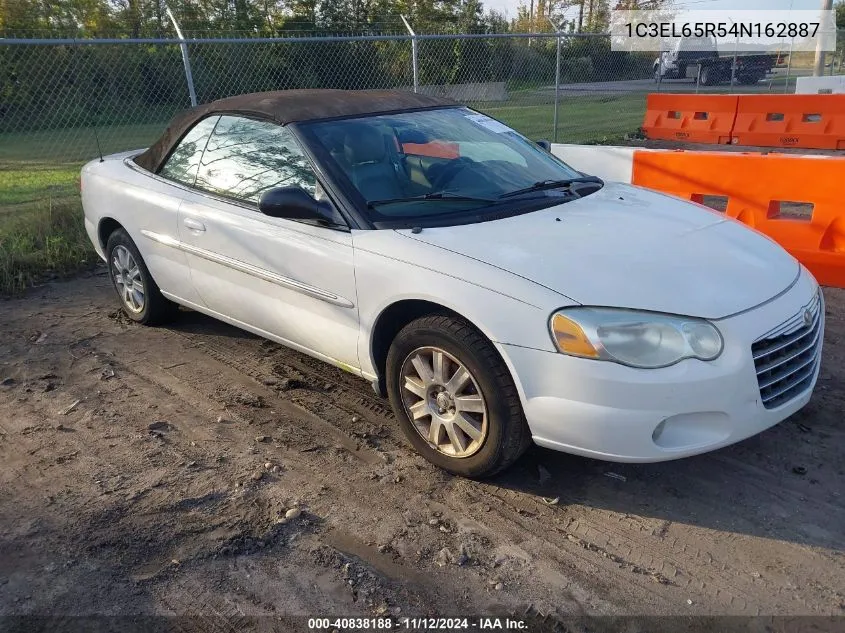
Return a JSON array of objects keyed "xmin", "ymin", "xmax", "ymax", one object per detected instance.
[{"xmin": 106, "ymin": 228, "xmax": 179, "ymax": 325}]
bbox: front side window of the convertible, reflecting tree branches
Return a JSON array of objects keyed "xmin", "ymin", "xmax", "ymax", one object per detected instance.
[{"xmin": 196, "ymin": 116, "xmax": 317, "ymax": 202}]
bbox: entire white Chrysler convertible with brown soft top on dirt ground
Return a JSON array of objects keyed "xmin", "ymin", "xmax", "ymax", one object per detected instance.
[{"xmin": 82, "ymin": 90, "xmax": 824, "ymax": 477}]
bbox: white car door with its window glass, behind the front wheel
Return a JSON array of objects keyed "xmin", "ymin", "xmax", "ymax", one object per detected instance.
[{"xmin": 179, "ymin": 115, "xmax": 359, "ymax": 370}]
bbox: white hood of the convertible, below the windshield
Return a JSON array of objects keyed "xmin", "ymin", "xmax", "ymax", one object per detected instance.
[{"xmin": 400, "ymin": 183, "xmax": 800, "ymax": 319}]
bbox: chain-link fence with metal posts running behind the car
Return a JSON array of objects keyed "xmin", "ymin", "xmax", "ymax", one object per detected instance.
[{"xmin": 0, "ymin": 33, "xmax": 842, "ymax": 213}]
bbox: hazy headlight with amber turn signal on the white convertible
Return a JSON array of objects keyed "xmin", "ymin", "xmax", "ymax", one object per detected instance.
[{"xmin": 549, "ymin": 307, "xmax": 723, "ymax": 369}]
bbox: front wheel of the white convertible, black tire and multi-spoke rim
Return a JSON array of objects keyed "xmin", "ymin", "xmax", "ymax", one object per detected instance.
[{"xmin": 386, "ymin": 314, "xmax": 531, "ymax": 478}]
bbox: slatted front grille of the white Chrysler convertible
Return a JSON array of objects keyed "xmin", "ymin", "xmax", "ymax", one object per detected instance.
[{"xmin": 751, "ymin": 291, "xmax": 822, "ymax": 409}]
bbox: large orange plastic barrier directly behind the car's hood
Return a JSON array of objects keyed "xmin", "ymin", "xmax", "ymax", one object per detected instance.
[{"xmin": 632, "ymin": 150, "xmax": 845, "ymax": 288}]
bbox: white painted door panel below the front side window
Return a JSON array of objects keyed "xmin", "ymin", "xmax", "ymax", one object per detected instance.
[{"xmin": 179, "ymin": 186, "xmax": 358, "ymax": 367}]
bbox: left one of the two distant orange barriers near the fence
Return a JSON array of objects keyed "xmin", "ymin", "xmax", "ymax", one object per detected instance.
[{"xmin": 643, "ymin": 94, "xmax": 739, "ymax": 144}]
